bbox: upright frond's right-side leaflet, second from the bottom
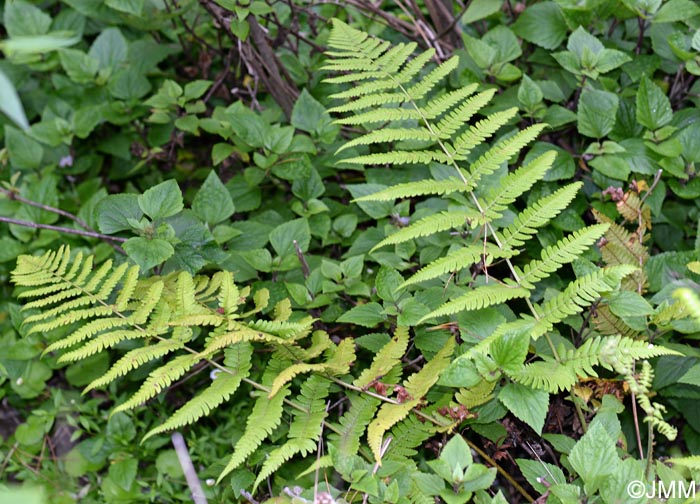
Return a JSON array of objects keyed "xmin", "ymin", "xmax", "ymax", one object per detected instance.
[{"xmin": 532, "ymin": 265, "xmax": 637, "ymax": 339}]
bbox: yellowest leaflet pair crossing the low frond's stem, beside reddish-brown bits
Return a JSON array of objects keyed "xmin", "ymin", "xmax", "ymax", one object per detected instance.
[{"xmin": 367, "ymin": 338, "xmax": 454, "ymax": 465}]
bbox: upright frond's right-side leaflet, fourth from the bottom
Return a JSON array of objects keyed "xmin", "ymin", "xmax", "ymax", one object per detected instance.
[{"xmin": 499, "ymin": 182, "xmax": 583, "ymax": 249}]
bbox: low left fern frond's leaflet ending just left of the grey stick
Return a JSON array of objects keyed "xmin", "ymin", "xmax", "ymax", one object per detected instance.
[{"xmin": 141, "ymin": 343, "xmax": 253, "ymax": 443}]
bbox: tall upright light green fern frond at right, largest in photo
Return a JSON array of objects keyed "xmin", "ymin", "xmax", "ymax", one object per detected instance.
[{"xmin": 325, "ymin": 20, "xmax": 673, "ymax": 438}]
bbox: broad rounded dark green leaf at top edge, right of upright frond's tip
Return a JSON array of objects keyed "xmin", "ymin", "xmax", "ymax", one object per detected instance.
[{"xmin": 513, "ymin": 2, "xmax": 568, "ymax": 50}]
